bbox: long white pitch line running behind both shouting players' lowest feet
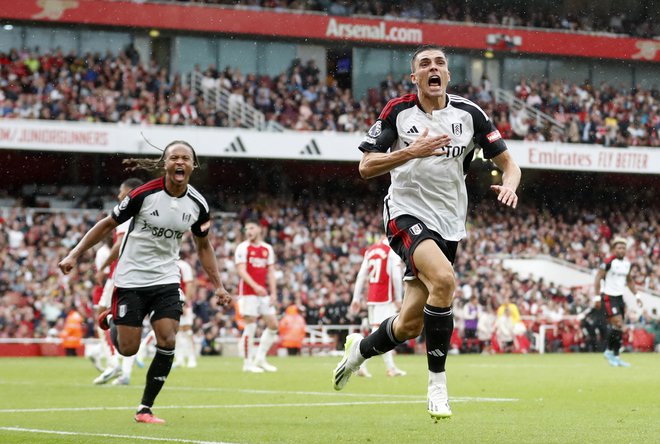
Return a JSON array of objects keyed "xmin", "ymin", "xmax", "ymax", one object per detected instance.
[{"xmin": 0, "ymin": 397, "xmax": 517, "ymax": 413}]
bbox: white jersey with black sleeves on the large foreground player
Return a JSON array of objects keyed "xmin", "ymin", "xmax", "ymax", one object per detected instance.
[{"xmin": 359, "ymin": 94, "xmax": 506, "ymax": 241}]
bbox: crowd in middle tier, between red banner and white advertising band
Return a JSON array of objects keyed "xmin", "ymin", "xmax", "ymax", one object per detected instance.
[{"xmin": 0, "ymin": 48, "xmax": 660, "ymax": 147}]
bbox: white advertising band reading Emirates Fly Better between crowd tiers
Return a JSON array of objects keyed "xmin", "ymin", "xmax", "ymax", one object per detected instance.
[{"xmin": 0, "ymin": 120, "xmax": 660, "ymax": 175}]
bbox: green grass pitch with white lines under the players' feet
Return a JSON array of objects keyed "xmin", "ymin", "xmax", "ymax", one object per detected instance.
[{"xmin": 0, "ymin": 354, "xmax": 660, "ymax": 444}]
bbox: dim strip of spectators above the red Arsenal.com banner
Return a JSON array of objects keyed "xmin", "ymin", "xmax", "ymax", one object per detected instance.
[{"xmin": 131, "ymin": 0, "xmax": 660, "ymax": 38}]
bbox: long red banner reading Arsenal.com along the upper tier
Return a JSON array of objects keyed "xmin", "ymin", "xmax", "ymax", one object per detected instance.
[{"xmin": 0, "ymin": 0, "xmax": 660, "ymax": 62}]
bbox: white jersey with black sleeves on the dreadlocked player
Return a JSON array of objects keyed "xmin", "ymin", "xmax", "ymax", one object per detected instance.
[{"xmin": 112, "ymin": 177, "xmax": 210, "ymax": 288}]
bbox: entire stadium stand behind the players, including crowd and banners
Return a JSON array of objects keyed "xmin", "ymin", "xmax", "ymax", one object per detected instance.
[{"xmin": 0, "ymin": 0, "xmax": 660, "ymax": 354}]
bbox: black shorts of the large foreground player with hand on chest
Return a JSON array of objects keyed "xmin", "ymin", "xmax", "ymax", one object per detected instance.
[{"xmin": 387, "ymin": 215, "xmax": 458, "ymax": 279}]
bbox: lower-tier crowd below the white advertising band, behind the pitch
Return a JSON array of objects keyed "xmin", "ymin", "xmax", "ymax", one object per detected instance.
[{"xmin": 0, "ymin": 183, "xmax": 660, "ymax": 351}]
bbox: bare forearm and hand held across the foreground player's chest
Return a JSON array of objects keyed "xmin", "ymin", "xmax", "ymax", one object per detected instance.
[{"xmin": 360, "ymin": 128, "xmax": 451, "ymax": 179}]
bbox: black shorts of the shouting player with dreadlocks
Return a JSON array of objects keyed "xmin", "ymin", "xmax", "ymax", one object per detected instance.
[{"xmin": 112, "ymin": 284, "xmax": 183, "ymax": 327}]
